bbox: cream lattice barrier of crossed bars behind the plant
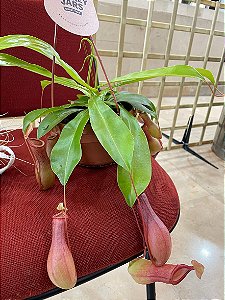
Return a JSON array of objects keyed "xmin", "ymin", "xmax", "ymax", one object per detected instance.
[{"xmin": 95, "ymin": 0, "xmax": 225, "ymax": 150}]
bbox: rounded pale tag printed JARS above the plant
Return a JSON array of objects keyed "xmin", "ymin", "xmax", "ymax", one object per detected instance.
[{"xmin": 44, "ymin": 0, "xmax": 99, "ymax": 36}]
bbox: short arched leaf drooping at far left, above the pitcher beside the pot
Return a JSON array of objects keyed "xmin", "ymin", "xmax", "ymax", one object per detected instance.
[{"xmin": 23, "ymin": 104, "xmax": 71, "ymax": 133}]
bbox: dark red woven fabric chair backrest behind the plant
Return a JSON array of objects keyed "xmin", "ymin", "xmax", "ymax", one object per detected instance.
[{"xmin": 0, "ymin": 0, "xmax": 93, "ymax": 116}]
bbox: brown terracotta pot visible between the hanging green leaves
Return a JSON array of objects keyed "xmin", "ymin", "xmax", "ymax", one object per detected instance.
[{"xmin": 79, "ymin": 123, "xmax": 115, "ymax": 167}]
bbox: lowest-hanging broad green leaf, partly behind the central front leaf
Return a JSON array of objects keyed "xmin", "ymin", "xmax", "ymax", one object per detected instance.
[{"xmin": 117, "ymin": 108, "xmax": 152, "ymax": 207}]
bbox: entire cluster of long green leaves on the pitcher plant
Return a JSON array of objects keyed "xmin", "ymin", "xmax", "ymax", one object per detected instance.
[{"xmin": 0, "ymin": 35, "xmax": 215, "ymax": 207}]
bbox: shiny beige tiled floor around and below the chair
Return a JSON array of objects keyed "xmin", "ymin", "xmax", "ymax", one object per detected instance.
[{"xmin": 1, "ymin": 110, "xmax": 224, "ymax": 300}]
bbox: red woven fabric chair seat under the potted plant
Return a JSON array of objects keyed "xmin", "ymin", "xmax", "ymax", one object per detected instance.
[{"xmin": 0, "ymin": 130, "xmax": 180, "ymax": 300}]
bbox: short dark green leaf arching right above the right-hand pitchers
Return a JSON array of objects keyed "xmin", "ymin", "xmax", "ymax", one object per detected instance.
[{"xmin": 111, "ymin": 92, "xmax": 157, "ymax": 119}]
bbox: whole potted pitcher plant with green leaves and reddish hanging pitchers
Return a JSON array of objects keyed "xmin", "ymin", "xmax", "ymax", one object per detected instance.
[{"xmin": 0, "ymin": 35, "xmax": 215, "ymax": 288}]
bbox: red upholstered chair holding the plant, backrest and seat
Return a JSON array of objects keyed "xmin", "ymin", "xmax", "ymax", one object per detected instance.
[{"xmin": 0, "ymin": 0, "xmax": 179, "ymax": 300}]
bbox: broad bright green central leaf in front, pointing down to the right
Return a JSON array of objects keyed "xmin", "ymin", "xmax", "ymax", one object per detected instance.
[{"xmin": 88, "ymin": 97, "xmax": 134, "ymax": 171}]
